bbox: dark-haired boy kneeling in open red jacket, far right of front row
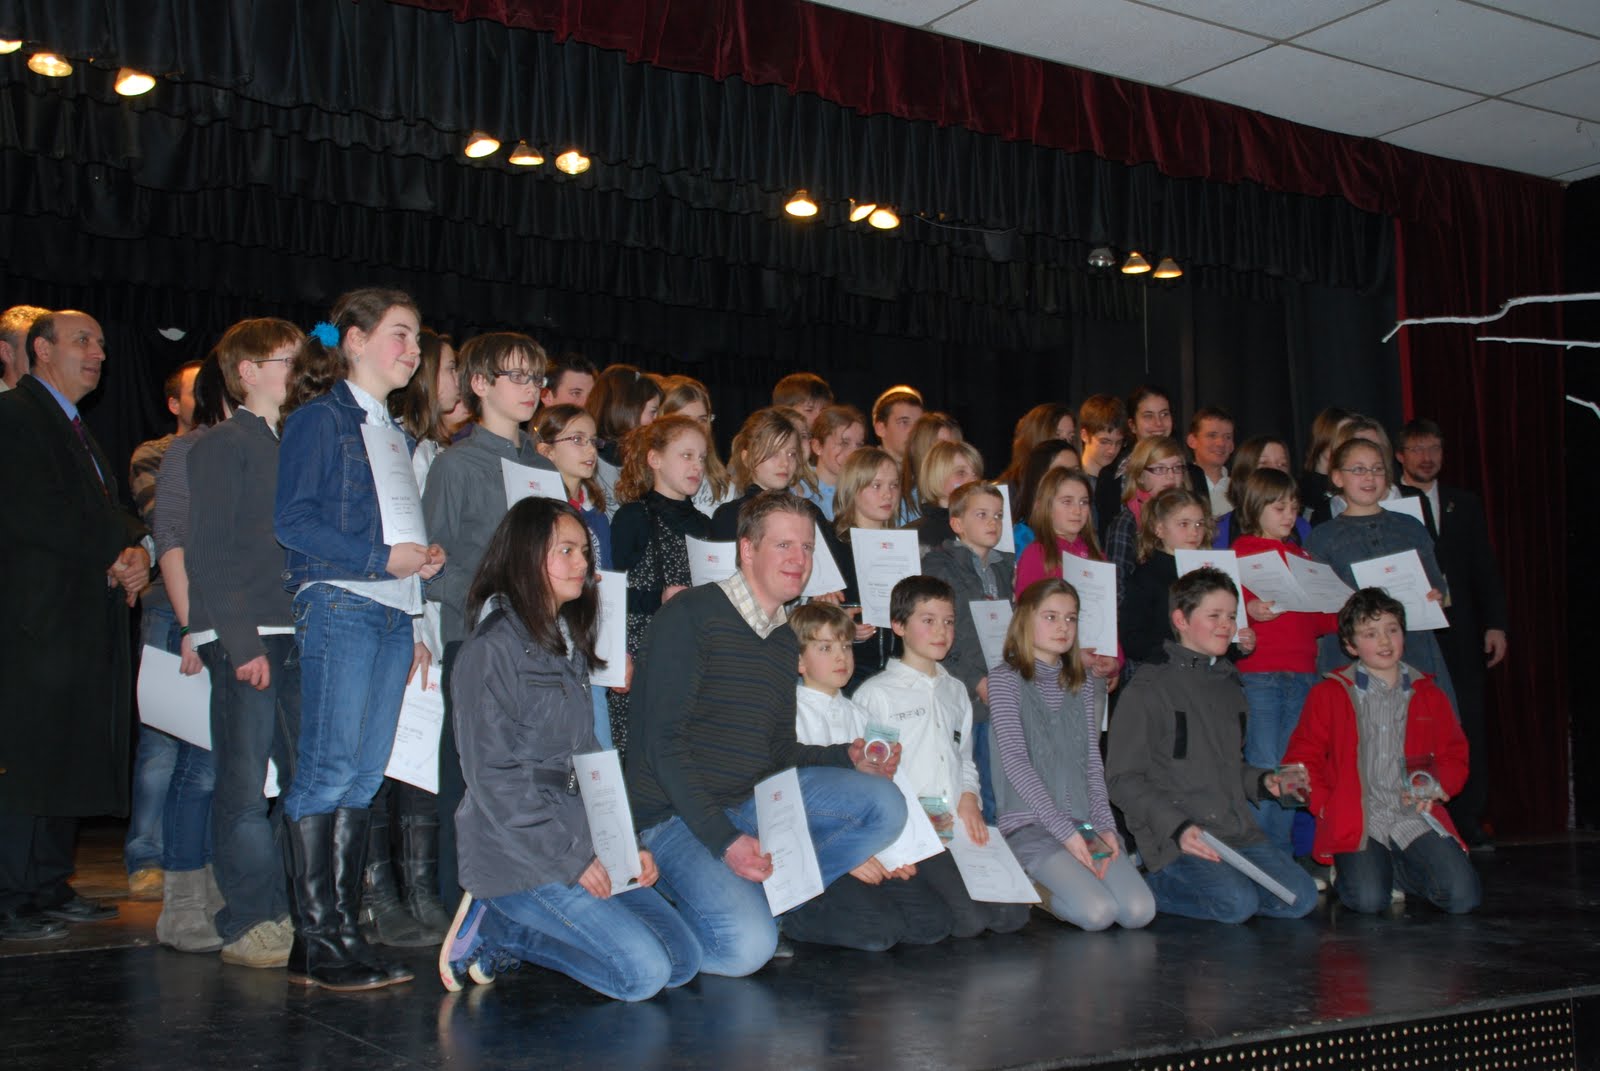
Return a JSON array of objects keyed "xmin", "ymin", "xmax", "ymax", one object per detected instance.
[{"xmin": 1283, "ymin": 588, "xmax": 1482, "ymax": 914}]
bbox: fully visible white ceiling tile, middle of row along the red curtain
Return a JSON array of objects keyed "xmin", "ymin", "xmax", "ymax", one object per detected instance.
[{"xmin": 1178, "ymin": 45, "xmax": 1482, "ymax": 138}]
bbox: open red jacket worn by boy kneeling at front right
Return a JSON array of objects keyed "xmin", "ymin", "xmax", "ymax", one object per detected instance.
[{"xmin": 1283, "ymin": 666, "xmax": 1467, "ymax": 863}]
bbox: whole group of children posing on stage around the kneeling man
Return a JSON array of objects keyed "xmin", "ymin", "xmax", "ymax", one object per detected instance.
[{"xmin": 124, "ymin": 290, "xmax": 1478, "ymax": 999}]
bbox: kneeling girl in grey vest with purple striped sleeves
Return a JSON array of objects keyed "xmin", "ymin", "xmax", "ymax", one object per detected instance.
[{"xmin": 989, "ymin": 578, "xmax": 1155, "ymax": 930}]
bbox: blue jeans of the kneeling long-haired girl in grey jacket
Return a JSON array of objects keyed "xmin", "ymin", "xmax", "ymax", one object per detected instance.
[{"xmin": 478, "ymin": 885, "xmax": 701, "ymax": 1001}]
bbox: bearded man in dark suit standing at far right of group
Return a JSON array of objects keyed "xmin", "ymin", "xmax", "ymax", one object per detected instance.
[{"xmin": 1395, "ymin": 419, "xmax": 1506, "ymax": 850}]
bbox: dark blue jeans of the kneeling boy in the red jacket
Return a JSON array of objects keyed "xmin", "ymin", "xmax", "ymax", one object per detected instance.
[{"xmin": 1333, "ymin": 832, "xmax": 1483, "ymax": 914}]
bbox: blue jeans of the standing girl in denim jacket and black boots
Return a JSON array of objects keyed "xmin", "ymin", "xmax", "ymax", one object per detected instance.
[{"xmin": 283, "ymin": 584, "xmax": 411, "ymax": 821}]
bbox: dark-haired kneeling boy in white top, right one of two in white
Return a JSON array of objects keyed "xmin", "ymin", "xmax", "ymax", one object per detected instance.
[{"xmin": 854, "ymin": 576, "xmax": 1029, "ymax": 937}]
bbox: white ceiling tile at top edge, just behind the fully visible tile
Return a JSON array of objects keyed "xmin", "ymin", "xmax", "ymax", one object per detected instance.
[{"xmin": 1294, "ymin": 0, "xmax": 1600, "ymax": 94}]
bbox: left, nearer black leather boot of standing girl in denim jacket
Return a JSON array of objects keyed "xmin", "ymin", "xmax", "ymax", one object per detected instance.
[{"xmin": 283, "ymin": 815, "xmax": 389, "ymax": 993}]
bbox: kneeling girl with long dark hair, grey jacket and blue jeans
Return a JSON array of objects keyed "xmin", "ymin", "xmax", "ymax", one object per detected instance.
[{"xmin": 438, "ymin": 498, "xmax": 701, "ymax": 1001}]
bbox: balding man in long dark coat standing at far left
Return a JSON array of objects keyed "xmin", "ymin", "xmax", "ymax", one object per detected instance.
[{"xmin": 0, "ymin": 311, "xmax": 150, "ymax": 940}]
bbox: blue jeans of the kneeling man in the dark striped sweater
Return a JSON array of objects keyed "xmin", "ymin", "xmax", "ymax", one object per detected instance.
[{"xmin": 640, "ymin": 767, "xmax": 906, "ymax": 978}]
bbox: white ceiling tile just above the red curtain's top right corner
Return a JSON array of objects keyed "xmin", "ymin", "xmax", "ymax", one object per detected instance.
[{"xmin": 1384, "ymin": 101, "xmax": 1600, "ymax": 178}]
